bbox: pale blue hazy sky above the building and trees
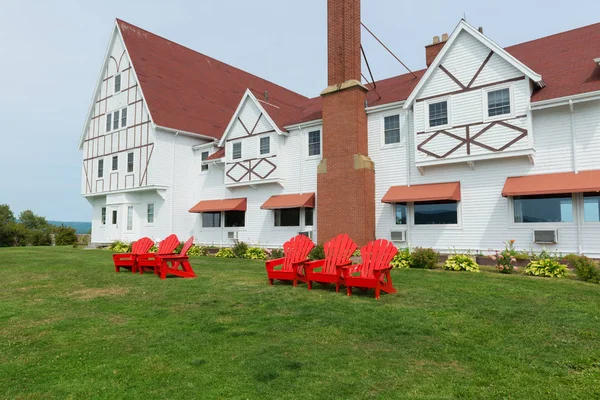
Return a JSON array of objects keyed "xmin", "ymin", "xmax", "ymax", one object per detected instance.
[{"xmin": 0, "ymin": 0, "xmax": 600, "ymax": 221}]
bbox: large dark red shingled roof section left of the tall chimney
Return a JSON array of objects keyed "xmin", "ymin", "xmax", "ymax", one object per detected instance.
[{"xmin": 117, "ymin": 19, "xmax": 308, "ymax": 139}]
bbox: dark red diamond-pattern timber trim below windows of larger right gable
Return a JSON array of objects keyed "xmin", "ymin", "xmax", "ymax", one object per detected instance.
[{"xmin": 417, "ymin": 117, "xmax": 528, "ymax": 159}]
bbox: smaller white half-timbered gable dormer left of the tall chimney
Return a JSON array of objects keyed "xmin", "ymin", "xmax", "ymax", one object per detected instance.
[{"xmin": 219, "ymin": 90, "xmax": 287, "ymax": 186}]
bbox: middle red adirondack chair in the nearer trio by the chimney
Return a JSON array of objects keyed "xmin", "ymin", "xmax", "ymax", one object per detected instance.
[{"xmin": 304, "ymin": 233, "xmax": 358, "ymax": 292}]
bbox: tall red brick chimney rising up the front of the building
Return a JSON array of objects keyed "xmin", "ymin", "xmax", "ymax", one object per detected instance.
[{"xmin": 317, "ymin": 0, "xmax": 375, "ymax": 246}]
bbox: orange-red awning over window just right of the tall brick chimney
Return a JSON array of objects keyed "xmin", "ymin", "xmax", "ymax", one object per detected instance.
[{"xmin": 381, "ymin": 182, "xmax": 460, "ymax": 203}]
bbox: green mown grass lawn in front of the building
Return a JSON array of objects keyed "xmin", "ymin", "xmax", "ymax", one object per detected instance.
[{"xmin": 0, "ymin": 248, "xmax": 600, "ymax": 399}]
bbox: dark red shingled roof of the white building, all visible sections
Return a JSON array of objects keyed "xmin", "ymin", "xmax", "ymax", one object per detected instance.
[{"xmin": 117, "ymin": 20, "xmax": 600, "ymax": 139}]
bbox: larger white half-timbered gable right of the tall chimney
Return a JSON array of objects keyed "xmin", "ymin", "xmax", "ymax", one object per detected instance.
[{"xmin": 404, "ymin": 21, "xmax": 544, "ymax": 168}]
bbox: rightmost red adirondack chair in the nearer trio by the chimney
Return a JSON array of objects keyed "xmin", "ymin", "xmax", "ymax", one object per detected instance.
[{"xmin": 342, "ymin": 239, "xmax": 398, "ymax": 299}]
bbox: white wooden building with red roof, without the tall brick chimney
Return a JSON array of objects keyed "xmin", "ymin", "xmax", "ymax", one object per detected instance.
[{"xmin": 79, "ymin": 14, "xmax": 600, "ymax": 257}]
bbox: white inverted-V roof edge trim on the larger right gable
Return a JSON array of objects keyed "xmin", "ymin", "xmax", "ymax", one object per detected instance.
[{"xmin": 404, "ymin": 19, "xmax": 545, "ymax": 108}]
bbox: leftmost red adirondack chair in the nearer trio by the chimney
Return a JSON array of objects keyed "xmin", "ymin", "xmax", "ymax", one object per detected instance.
[{"xmin": 265, "ymin": 235, "xmax": 315, "ymax": 286}]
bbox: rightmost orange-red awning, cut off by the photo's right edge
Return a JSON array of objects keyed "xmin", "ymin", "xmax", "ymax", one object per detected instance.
[{"xmin": 502, "ymin": 171, "xmax": 600, "ymax": 197}]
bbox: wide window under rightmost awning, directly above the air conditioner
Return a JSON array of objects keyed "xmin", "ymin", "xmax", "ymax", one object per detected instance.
[{"xmin": 513, "ymin": 195, "xmax": 573, "ymax": 223}]
